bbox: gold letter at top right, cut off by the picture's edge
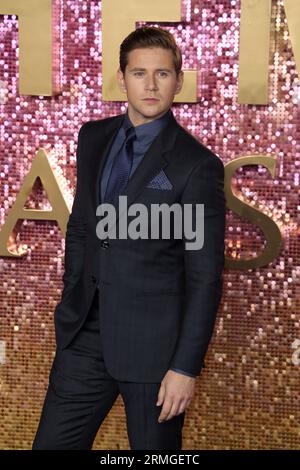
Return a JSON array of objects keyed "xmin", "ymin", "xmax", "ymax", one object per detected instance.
[{"xmin": 238, "ymin": 0, "xmax": 300, "ymax": 104}]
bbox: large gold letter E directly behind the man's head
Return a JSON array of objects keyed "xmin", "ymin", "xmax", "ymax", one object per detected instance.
[{"xmin": 102, "ymin": 0, "xmax": 197, "ymax": 103}]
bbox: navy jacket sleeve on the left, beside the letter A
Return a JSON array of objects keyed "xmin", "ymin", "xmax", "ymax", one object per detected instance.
[{"xmin": 62, "ymin": 124, "xmax": 87, "ymax": 297}]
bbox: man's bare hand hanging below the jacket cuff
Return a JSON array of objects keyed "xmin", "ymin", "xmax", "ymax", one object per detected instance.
[{"xmin": 156, "ymin": 369, "xmax": 196, "ymax": 423}]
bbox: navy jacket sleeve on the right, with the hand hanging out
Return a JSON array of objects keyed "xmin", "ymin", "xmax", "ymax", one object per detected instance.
[{"xmin": 170, "ymin": 154, "xmax": 226, "ymax": 376}]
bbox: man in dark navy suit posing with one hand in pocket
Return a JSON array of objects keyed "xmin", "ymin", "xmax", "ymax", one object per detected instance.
[{"xmin": 33, "ymin": 27, "xmax": 225, "ymax": 450}]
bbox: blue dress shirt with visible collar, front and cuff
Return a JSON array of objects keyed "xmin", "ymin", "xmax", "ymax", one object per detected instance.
[{"xmin": 99, "ymin": 109, "xmax": 196, "ymax": 377}]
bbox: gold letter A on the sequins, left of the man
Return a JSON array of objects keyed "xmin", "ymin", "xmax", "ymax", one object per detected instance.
[{"xmin": 0, "ymin": 149, "xmax": 70, "ymax": 257}]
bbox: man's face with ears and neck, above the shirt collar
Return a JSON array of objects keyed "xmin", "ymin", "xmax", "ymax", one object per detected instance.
[{"xmin": 117, "ymin": 47, "xmax": 183, "ymax": 126}]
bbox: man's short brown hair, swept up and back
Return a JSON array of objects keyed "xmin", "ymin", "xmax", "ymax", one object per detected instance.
[{"xmin": 120, "ymin": 26, "xmax": 182, "ymax": 76}]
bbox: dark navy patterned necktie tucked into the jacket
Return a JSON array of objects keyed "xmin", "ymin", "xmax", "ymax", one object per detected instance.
[{"xmin": 104, "ymin": 126, "xmax": 136, "ymax": 204}]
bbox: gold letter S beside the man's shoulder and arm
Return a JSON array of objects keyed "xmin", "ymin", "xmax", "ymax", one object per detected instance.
[{"xmin": 225, "ymin": 155, "xmax": 282, "ymax": 269}]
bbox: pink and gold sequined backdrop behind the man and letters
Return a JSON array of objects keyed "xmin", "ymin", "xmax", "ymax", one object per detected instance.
[{"xmin": 0, "ymin": 0, "xmax": 300, "ymax": 449}]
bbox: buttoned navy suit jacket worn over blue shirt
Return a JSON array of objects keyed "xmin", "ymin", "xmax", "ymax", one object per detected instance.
[{"xmin": 54, "ymin": 113, "xmax": 225, "ymax": 383}]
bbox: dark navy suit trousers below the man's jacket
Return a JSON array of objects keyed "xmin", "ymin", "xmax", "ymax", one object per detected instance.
[{"xmin": 32, "ymin": 289, "xmax": 185, "ymax": 450}]
